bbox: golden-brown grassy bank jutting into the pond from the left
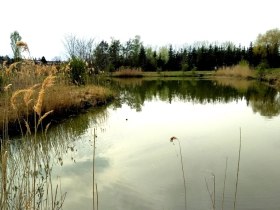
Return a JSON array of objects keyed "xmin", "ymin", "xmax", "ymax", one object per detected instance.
[{"xmin": 0, "ymin": 61, "xmax": 114, "ymax": 134}]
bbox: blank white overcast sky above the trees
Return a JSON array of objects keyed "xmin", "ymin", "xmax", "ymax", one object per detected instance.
[{"xmin": 0, "ymin": 0, "xmax": 280, "ymax": 60}]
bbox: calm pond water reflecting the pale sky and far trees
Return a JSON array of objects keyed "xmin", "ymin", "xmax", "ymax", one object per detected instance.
[{"xmin": 12, "ymin": 79, "xmax": 280, "ymax": 210}]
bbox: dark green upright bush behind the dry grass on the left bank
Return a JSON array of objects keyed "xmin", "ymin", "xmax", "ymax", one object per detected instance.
[{"xmin": 70, "ymin": 58, "xmax": 87, "ymax": 85}]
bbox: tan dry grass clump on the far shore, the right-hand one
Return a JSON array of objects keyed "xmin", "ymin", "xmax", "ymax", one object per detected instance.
[{"xmin": 215, "ymin": 65, "xmax": 255, "ymax": 79}]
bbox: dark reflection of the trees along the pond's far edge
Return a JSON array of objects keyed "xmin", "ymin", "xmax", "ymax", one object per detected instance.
[{"xmin": 112, "ymin": 79, "xmax": 280, "ymax": 118}]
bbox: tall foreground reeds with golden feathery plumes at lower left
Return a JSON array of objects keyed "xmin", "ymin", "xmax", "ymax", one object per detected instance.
[{"xmin": 0, "ymin": 75, "xmax": 66, "ymax": 209}]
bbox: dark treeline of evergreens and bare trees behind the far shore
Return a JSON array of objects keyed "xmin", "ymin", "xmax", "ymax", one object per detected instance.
[{"xmin": 65, "ymin": 29, "xmax": 280, "ymax": 72}]
